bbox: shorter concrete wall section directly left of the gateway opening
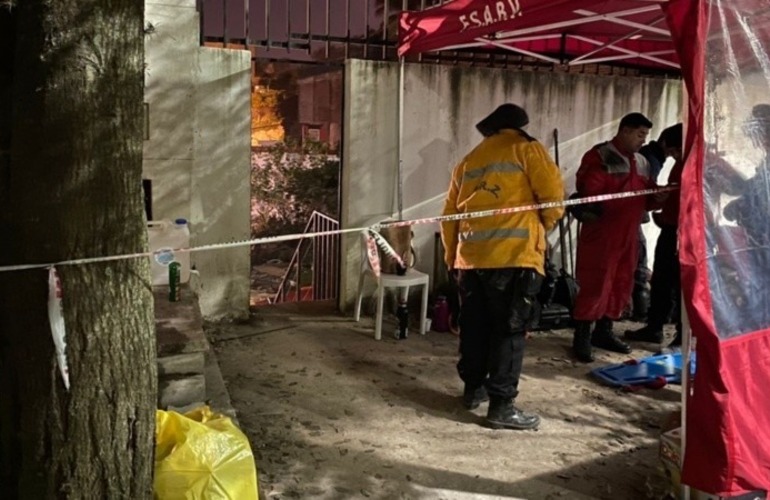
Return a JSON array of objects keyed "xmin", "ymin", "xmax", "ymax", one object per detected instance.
[{"xmin": 191, "ymin": 52, "xmax": 251, "ymax": 318}]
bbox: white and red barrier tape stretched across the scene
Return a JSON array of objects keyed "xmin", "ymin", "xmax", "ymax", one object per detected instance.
[{"xmin": 0, "ymin": 186, "xmax": 679, "ymax": 272}]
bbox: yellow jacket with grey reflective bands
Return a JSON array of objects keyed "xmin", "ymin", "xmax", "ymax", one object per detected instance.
[{"xmin": 441, "ymin": 129, "xmax": 564, "ymax": 274}]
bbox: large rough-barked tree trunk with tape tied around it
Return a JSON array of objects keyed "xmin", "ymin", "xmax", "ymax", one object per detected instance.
[{"xmin": 0, "ymin": 0, "xmax": 157, "ymax": 499}]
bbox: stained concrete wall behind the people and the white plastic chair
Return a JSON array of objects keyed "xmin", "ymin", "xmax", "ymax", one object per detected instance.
[{"xmin": 340, "ymin": 60, "xmax": 682, "ymax": 308}]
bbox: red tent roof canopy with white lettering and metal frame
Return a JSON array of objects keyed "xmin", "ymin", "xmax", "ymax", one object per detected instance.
[{"xmin": 398, "ymin": 0, "xmax": 678, "ymax": 68}]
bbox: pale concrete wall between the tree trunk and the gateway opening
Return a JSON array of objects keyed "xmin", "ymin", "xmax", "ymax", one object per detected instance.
[{"xmin": 144, "ymin": 0, "xmax": 251, "ymax": 318}]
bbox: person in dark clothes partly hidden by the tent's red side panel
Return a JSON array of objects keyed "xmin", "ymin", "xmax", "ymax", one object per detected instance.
[{"xmin": 625, "ymin": 123, "xmax": 684, "ymax": 346}]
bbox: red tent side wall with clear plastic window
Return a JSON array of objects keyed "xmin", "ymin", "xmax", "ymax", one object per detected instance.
[{"xmin": 666, "ymin": 0, "xmax": 770, "ymax": 495}]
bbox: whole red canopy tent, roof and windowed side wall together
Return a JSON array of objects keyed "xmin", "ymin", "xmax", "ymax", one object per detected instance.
[{"xmin": 399, "ymin": 0, "xmax": 770, "ymax": 496}]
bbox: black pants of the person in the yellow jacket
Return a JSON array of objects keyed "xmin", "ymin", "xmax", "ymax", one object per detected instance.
[{"xmin": 457, "ymin": 268, "xmax": 543, "ymax": 399}]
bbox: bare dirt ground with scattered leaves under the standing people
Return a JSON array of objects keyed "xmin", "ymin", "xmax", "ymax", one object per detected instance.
[{"xmin": 207, "ymin": 304, "xmax": 680, "ymax": 499}]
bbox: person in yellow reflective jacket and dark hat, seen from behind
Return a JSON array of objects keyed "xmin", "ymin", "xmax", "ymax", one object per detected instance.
[{"xmin": 441, "ymin": 104, "xmax": 564, "ymax": 429}]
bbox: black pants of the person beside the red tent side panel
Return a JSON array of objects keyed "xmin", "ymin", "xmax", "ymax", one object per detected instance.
[{"xmin": 647, "ymin": 226, "xmax": 681, "ymax": 329}]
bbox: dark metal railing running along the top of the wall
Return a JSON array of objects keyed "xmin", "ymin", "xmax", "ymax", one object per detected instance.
[{"xmin": 197, "ymin": 0, "xmax": 667, "ymax": 76}]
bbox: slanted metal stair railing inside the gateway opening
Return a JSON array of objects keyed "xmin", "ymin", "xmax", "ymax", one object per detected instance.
[{"xmin": 272, "ymin": 211, "xmax": 340, "ymax": 304}]
